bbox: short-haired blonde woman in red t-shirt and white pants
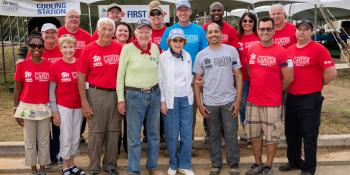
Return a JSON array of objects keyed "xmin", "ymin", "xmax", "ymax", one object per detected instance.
[{"xmin": 49, "ymin": 34, "xmax": 85, "ymax": 175}]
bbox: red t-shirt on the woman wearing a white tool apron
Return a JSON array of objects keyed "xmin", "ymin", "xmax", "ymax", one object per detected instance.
[{"xmin": 14, "ymin": 59, "xmax": 51, "ymax": 104}]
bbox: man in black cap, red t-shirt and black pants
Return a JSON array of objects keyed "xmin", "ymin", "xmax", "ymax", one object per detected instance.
[{"xmin": 279, "ymin": 19, "xmax": 337, "ymax": 175}]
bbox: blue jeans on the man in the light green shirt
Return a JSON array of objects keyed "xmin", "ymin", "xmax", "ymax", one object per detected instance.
[{"xmin": 126, "ymin": 88, "xmax": 161, "ymax": 174}]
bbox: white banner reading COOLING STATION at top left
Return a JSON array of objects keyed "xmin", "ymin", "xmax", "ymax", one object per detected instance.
[{"xmin": 0, "ymin": 0, "xmax": 80, "ymax": 17}]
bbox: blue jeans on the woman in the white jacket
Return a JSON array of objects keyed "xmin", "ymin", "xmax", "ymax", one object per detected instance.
[{"xmin": 163, "ymin": 97, "xmax": 193, "ymax": 170}]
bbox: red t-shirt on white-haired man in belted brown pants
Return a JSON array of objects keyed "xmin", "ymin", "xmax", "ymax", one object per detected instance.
[{"xmin": 79, "ymin": 41, "xmax": 123, "ymax": 88}]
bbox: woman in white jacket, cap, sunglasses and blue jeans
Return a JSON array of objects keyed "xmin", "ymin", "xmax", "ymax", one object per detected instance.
[{"xmin": 158, "ymin": 29, "xmax": 194, "ymax": 175}]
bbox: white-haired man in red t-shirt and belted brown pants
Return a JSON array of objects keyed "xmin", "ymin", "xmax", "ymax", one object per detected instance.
[{"xmin": 78, "ymin": 18, "xmax": 122, "ymax": 174}]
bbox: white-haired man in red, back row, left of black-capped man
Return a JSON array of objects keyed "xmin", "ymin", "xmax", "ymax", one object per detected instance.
[{"xmin": 269, "ymin": 3, "xmax": 296, "ymax": 49}]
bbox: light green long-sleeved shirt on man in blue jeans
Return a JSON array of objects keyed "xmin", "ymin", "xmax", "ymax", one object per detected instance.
[{"xmin": 117, "ymin": 43, "xmax": 159, "ymax": 102}]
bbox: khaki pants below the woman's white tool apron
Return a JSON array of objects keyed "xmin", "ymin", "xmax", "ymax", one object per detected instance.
[{"xmin": 23, "ymin": 118, "xmax": 51, "ymax": 166}]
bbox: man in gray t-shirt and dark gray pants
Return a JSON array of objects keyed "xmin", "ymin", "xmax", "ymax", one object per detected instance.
[{"xmin": 193, "ymin": 23, "xmax": 243, "ymax": 175}]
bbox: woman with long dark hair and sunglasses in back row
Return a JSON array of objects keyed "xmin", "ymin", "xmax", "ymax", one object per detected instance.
[{"xmin": 238, "ymin": 12, "xmax": 260, "ymax": 141}]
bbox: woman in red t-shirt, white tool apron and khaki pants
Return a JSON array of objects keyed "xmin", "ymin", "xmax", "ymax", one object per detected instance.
[{"xmin": 13, "ymin": 33, "xmax": 52, "ymax": 174}]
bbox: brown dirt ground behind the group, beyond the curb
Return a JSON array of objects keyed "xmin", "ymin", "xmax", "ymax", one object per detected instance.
[{"xmin": 0, "ymin": 69, "xmax": 350, "ymax": 142}]
